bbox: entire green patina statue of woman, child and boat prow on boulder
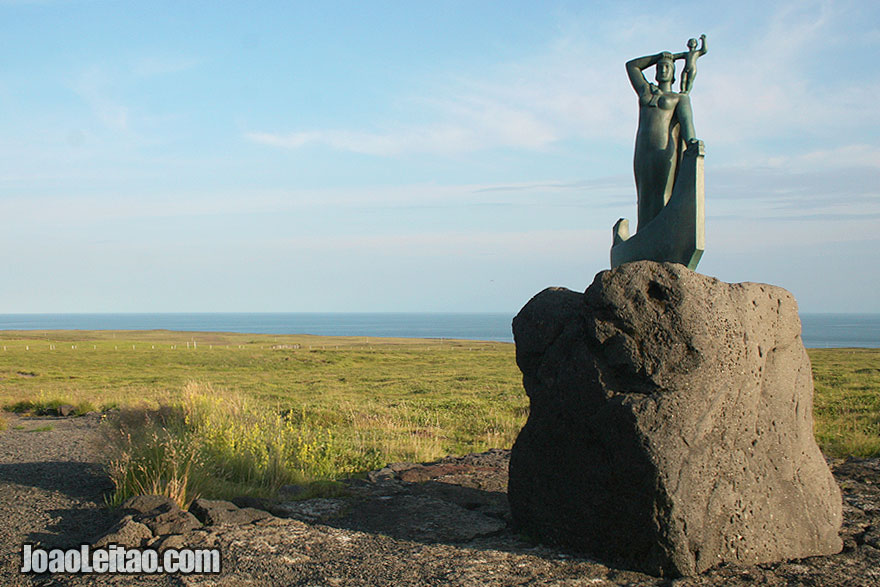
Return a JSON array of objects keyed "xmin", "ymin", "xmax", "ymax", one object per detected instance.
[{"xmin": 611, "ymin": 35, "xmax": 706, "ymax": 269}]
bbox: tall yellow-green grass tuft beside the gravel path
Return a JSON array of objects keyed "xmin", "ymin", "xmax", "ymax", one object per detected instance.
[{"xmin": 101, "ymin": 383, "xmax": 379, "ymax": 507}]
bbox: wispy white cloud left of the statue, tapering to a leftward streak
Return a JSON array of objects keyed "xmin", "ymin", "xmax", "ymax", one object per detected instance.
[{"xmin": 244, "ymin": 23, "xmax": 635, "ymax": 157}]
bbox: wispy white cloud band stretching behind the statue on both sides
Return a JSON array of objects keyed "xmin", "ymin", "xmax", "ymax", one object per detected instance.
[{"xmin": 245, "ymin": 2, "xmax": 880, "ymax": 177}]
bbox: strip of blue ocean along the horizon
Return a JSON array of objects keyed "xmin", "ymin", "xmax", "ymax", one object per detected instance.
[{"xmin": 0, "ymin": 313, "xmax": 880, "ymax": 348}]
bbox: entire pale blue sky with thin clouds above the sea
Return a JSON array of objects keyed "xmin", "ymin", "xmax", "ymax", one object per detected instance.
[{"xmin": 0, "ymin": 0, "xmax": 880, "ymax": 313}]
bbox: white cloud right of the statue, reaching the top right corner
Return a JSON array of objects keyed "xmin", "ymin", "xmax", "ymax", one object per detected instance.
[{"xmin": 694, "ymin": 2, "xmax": 880, "ymax": 151}]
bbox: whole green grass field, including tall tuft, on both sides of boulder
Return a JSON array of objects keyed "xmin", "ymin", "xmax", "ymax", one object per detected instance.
[{"xmin": 0, "ymin": 331, "xmax": 880, "ymax": 501}]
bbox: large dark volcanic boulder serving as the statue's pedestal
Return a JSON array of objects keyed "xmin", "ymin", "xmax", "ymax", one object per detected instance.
[{"xmin": 508, "ymin": 261, "xmax": 842, "ymax": 576}]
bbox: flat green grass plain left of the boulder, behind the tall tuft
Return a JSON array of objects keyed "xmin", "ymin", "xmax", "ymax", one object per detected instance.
[{"xmin": 0, "ymin": 331, "xmax": 528, "ymax": 452}]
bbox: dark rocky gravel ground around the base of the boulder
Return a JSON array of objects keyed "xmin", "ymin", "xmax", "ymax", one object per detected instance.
[{"xmin": 0, "ymin": 415, "xmax": 880, "ymax": 587}]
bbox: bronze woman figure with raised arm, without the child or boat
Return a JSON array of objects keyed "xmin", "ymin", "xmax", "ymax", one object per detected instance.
[{"xmin": 626, "ymin": 52, "xmax": 699, "ymax": 230}]
